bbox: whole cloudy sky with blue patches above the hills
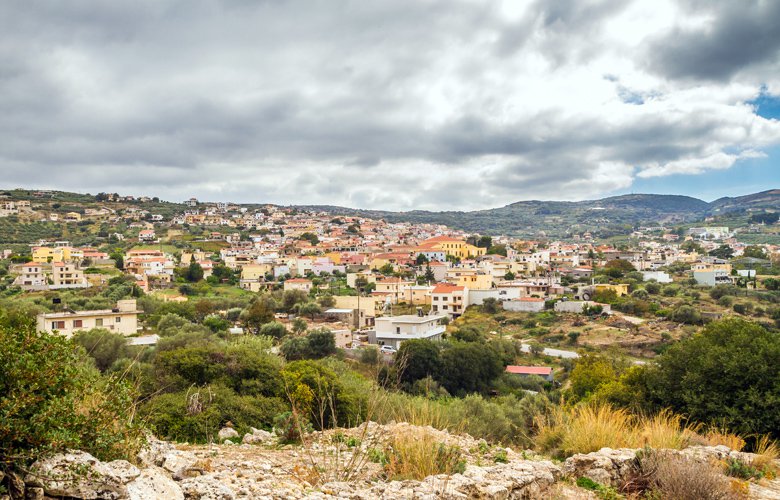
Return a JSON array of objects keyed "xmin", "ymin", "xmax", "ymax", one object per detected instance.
[{"xmin": 0, "ymin": 0, "xmax": 780, "ymax": 210}]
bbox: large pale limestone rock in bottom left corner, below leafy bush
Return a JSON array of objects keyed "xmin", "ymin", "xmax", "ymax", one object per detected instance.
[{"xmin": 25, "ymin": 451, "xmax": 131, "ymax": 500}]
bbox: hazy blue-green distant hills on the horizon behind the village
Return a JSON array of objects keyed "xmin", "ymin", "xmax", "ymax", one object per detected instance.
[{"xmin": 302, "ymin": 190, "xmax": 780, "ymax": 238}]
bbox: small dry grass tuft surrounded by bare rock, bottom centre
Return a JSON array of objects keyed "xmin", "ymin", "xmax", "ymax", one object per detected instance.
[{"xmin": 385, "ymin": 428, "xmax": 465, "ymax": 480}]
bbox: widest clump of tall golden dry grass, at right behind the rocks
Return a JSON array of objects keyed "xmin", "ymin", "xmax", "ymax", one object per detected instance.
[{"xmin": 535, "ymin": 404, "xmax": 698, "ymax": 457}]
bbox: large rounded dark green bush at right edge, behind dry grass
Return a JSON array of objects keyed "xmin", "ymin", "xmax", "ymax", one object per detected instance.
[{"xmin": 643, "ymin": 318, "xmax": 780, "ymax": 438}]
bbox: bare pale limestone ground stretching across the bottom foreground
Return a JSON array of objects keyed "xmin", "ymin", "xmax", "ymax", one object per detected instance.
[{"xmin": 7, "ymin": 423, "xmax": 780, "ymax": 500}]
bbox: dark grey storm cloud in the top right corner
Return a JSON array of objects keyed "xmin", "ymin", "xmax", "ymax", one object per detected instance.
[{"xmin": 646, "ymin": 0, "xmax": 780, "ymax": 80}]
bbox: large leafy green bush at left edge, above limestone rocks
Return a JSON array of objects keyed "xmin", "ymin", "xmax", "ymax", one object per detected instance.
[{"xmin": 0, "ymin": 323, "xmax": 142, "ymax": 467}]
